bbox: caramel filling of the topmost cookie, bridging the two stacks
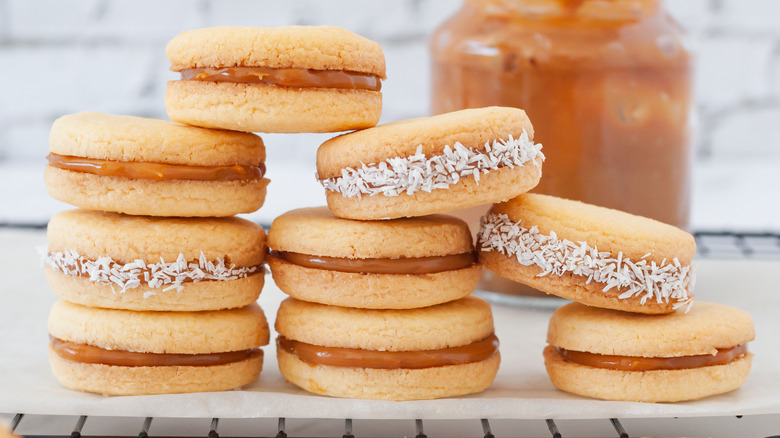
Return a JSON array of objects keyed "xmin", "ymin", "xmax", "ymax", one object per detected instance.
[{"xmin": 181, "ymin": 67, "xmax": 382, "ymax": 91}]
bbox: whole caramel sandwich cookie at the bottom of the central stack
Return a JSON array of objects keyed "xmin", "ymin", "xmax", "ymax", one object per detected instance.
[{"xmin": 276, "ymin": 296, "xmax": 501, "ymax": 400}]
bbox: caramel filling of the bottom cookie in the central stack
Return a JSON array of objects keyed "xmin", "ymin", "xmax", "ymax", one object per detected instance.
[{"xmin": 276, "ymin": 334, "xmax": 498, "ymax": 370}]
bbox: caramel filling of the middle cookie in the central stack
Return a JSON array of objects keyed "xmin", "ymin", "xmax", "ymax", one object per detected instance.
[{"xmin": 271, "ymin": 251, "xmax": 476, "ymax": 275}]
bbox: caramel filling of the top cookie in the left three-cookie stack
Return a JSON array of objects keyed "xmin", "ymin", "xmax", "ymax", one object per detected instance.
[{"xmin": 46, "ymin": 154, "xmax": 265, "ymax": 181}]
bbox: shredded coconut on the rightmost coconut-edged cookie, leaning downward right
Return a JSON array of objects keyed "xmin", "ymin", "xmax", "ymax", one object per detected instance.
[{"xmin": 477, "ymin": 213, "xmax": 694, "ymax": 309}]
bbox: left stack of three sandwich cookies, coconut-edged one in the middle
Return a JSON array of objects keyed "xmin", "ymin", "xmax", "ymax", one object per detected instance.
[{"xmin": 44, "ymin": 113, "xmax": 269, "ymax": 395}]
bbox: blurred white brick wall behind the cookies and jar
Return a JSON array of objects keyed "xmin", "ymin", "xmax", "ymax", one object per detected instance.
[{"xmin": 0, "ymin": 0, "xmax": 780, "ymax": 162}]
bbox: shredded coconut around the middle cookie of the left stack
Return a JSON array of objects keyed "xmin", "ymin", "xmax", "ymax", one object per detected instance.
[{"xmin": 41, "ymin": 249, "xmax": 265, "ymax": 298}]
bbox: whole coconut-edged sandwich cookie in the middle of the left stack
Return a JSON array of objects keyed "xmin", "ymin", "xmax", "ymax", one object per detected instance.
[{"xmin": 43, "ymin": 210, "xmax": 265, "ymax": 311}]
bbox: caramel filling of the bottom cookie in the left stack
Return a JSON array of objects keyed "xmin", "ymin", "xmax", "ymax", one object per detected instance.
[{"xmin": 50, "ymin": 336, "xmax": 263, "ymax": 367}]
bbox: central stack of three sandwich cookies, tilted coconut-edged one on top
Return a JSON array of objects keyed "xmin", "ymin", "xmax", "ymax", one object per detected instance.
[{"xmin": 268, "ymin": 108, "xmax": 543, "ymax": 400}]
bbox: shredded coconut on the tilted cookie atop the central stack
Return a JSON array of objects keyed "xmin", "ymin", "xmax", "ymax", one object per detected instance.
[{"xmin": 317, "ymin": 130, "xmax": 544, "ymax": 198}]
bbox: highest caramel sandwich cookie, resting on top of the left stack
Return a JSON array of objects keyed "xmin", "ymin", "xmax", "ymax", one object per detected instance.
[{"xmin": 165, "ymin": 26, "xmax": 385, "ymax": 132}]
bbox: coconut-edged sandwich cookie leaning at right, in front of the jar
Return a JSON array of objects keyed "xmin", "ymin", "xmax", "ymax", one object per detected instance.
[{"xmin": 477, "ymin": 194, "xmax": 696, "ymax": 313}]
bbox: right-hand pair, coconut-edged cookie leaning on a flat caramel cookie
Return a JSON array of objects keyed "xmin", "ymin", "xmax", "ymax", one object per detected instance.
[{"xmin": 477, "ymin": 194, "xmax": 755, "ymax": 402}]
